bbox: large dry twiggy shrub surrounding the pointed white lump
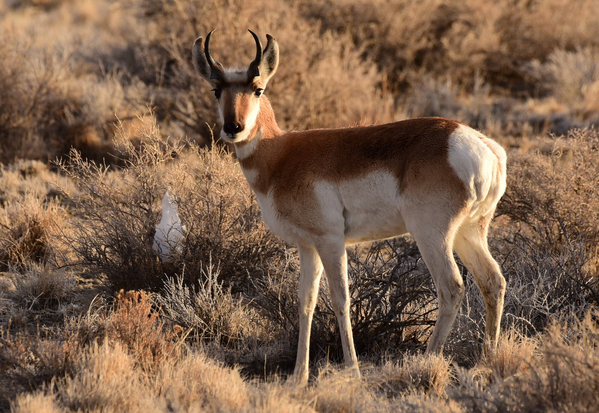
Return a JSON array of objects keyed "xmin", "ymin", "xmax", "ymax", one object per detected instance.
[{"xmin": 61, "ymin": 113, "xmax": 283, "ymax": 289}]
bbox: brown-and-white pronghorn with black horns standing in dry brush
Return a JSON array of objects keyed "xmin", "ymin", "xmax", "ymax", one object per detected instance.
[{"xmin": 192, "ymin": 30, "xmax": 506, "ymax": 385}]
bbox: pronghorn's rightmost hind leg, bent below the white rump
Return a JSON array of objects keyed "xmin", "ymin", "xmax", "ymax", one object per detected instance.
[{"xmin": 454, "ymin": 214, "xmax": 506, "ymax": 355}]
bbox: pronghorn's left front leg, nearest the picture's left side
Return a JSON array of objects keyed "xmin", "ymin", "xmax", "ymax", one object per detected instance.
[{"xmin": 293, "ymin": 246, "xmax": 322, "ymax": 386}]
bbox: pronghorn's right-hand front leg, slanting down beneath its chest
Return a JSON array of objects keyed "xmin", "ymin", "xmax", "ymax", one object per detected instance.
[{"xmin": 319, "ymin": 242, "xmax": 360, "ymax": 377}]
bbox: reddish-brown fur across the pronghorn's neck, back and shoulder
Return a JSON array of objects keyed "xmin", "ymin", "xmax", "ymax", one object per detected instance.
[{"xmin": 240, "ymin": 114, "xmax": 466, "ymax": 240}]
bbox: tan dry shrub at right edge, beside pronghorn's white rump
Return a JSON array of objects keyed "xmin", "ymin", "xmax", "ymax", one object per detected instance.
[{"xmin": 498, "ymin": 129, "xmax": 599, "ymax": 296}]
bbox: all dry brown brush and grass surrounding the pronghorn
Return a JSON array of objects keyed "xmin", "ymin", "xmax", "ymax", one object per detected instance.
[{"xmin": 0, "ymin": 0, "xmax": 599, "ymax": 412}]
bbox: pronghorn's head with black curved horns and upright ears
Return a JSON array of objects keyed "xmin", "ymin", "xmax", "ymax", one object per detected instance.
[{"xmin": 192, "ymin": 29, "xmax": 279, "ymax": 143}]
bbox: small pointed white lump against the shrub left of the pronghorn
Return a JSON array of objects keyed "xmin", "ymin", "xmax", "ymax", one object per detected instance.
[{"xmin": 152, "ymin": 191, "xmax": 187, "ymax": 262}]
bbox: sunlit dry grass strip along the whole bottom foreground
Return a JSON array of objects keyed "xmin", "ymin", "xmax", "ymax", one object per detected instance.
[{"xmin": 1, "ymin": 282, "xmax": 598, "ymax": 412}]
